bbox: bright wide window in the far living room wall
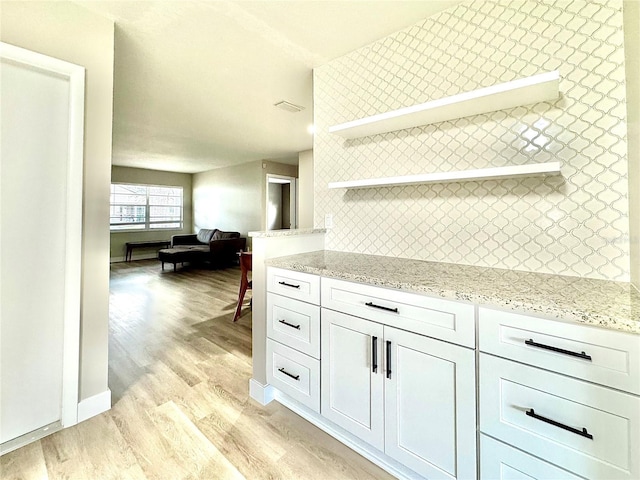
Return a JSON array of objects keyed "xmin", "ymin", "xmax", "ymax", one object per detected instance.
[{"xmin": 111, "ymin": 183, "xmax": 182, "ymax": 230}]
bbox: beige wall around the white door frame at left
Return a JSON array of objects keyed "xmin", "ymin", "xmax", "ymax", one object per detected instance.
[{"xmin": 0, "ymin": 1, "xmax": 114, "ymax": 400}]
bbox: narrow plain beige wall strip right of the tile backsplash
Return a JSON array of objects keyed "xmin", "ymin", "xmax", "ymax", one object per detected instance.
[{"xmin": 624, "ymin": 1, "xmax": 640, "ymax": 290}]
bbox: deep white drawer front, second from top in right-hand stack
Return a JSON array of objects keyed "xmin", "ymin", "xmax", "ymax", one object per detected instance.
[{"xmin": 480, "ymin": 353, "xmax": 640, "ymax": 479}]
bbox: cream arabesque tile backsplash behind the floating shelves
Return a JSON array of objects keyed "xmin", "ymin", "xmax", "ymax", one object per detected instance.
[{"xmin": 314, "ymin": 0, "xmax": 629, "ymax": 281}]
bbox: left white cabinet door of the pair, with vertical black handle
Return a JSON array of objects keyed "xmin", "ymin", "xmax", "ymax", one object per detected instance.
[{"xmin": 321, "ymin": 309, "xmax": 384, "ymax": 450}]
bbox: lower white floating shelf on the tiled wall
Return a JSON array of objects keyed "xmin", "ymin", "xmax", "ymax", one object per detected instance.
[{"xmin": 329, "ymin": 162, "xmax": 560, "ymax": 188}]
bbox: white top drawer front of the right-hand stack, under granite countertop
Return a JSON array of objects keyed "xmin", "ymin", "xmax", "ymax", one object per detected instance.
[{"xmin": 479, "ymin": 307, "xmax": 640, "ymax": 394}]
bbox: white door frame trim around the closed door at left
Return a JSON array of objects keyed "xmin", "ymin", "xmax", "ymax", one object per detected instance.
[{"xmin": 0, "ymin": 42, "xmax": 85, "ymax": 432}]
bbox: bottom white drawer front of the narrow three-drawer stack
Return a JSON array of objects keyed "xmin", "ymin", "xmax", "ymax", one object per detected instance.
[{"xmin": 267, "ymin": 339, "xmax": 320, "ymax": 413}]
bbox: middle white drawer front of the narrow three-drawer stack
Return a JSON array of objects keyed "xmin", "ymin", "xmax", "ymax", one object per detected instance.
[{"xmin": 267, "ymin": 293, "xmax": 320, "ymax": 359}]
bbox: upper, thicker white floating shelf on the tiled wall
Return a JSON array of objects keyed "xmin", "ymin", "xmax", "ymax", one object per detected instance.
[{"xmin": 329, "ymin": 70, "xmax": 560, "ymax": 138}]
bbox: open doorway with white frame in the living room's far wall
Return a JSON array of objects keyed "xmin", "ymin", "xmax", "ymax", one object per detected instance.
[{"xmin": 266, "ymin": 174, "xmax": 298, "ymax": 230}]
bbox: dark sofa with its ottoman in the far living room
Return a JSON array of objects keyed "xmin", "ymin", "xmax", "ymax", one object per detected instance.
[{"xmin": 158, "ymin": 228, "xmax": 247, "ymax": 271}]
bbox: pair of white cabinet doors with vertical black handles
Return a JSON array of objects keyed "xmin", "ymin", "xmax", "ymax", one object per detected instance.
[{"xmin": 321, "ymin": 309, "xmax": 476, "ymax": 479}]
